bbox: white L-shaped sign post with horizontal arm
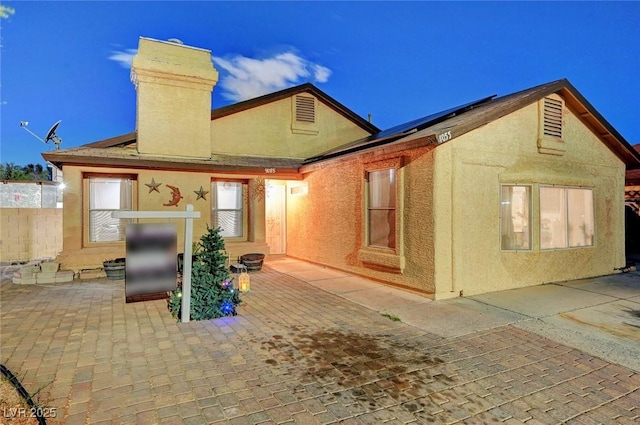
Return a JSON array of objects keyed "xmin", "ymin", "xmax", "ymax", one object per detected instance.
[{"xmin": 111, "ymin": 204, "xmax": 200, "ymax": 323}]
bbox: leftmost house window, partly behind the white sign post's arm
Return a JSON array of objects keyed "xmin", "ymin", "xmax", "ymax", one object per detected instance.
[{"xmin": 87, "ymin": 177, "xmax": 133, "ymax": 242}]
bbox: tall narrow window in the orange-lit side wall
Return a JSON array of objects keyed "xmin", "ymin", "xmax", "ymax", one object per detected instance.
[{"xmin": 367, "ymin": 168, "xmax": 396, "ymax": 249}]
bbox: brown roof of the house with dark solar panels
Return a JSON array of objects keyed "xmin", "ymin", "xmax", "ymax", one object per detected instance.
[{"xmin": 42, "ymin": 79, "xmax": 640, "ymax": 176}]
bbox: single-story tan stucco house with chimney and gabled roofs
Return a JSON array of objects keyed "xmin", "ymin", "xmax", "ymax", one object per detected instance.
[{"xmin": 43, "ymin": 38, "xmax": 640, "ymax": 299}]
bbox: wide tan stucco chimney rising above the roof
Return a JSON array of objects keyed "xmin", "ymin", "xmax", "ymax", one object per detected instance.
[{"xmin": 131, "ymin": 37, "xmax": 218, "ymax": 159}]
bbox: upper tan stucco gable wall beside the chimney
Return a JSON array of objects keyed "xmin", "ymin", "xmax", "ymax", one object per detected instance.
[{"xmin": 211, "ymin": 98, "xmax": 369, "ymax": 158}]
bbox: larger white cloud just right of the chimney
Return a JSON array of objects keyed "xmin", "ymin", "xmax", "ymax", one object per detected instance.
[{"xmin": 213, "ymin": 52, "xmax": 331, "ymax": 102}]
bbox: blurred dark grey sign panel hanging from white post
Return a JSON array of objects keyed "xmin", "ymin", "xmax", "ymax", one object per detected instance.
[{"xmin": 125, "ymin": 223, "xmax": 177, "ymax": 302}]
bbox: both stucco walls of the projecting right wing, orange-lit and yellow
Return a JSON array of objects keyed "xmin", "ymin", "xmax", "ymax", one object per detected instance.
[{"xmin": 287, "ymin": 96, "xmax": 625, "ymax": 298}]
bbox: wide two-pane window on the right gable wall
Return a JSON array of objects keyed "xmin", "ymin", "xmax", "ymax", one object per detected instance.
[{"xmin": 540, "ymin": 187, "xmax": 594, "ymax": 249}]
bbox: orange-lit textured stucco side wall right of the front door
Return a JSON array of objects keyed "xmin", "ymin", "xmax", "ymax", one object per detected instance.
[{"xmin": 287, "ymin": 148, "xmax": 435, "ymax": 293}]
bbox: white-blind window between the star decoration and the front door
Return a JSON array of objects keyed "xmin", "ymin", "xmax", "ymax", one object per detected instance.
[{"xmin": 211, "ymin": 181, "xmax": 247, "ymax": 238}]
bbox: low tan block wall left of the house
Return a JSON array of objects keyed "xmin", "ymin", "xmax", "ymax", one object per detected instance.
[{"xmin": 0, "ymin": 208, "xmax": 62, "ymax": 263}]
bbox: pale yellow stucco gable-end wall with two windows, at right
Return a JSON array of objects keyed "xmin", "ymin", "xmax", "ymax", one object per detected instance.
[{"xmin": 435, "ymin": 104, "xmax": 624, "ymax": 298}]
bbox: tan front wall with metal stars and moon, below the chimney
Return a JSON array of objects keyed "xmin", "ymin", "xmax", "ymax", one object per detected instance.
[{"xmin": 53, "ymin": 166, "xmax": 268, "ymax": 270}]
